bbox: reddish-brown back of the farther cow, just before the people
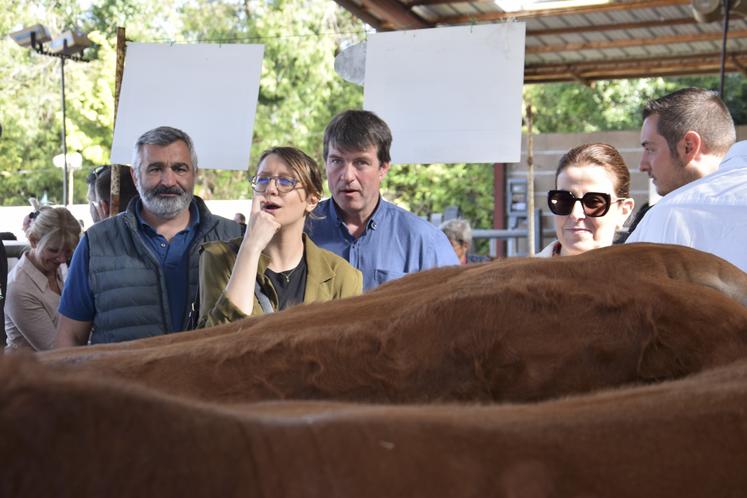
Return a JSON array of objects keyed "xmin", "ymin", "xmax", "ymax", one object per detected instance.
[{"xmin": 39, "ymin": 244, "xmax": 747, "ymax": 403}]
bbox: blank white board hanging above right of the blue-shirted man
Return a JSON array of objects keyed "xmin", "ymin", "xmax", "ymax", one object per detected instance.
[{"xmin": 364, "ymin": 22, "xmax": 526, "ymax": 163}]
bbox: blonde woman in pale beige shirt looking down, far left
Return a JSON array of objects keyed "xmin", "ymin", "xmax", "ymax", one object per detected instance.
[{"xmin": 5, "ymin": 207, "xmax": 81, "ymax": 351}]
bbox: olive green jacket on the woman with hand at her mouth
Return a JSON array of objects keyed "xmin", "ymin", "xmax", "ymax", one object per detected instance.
[{"xmin": 198, "ymin": 234, "xmax": 363, "ymax": 327}]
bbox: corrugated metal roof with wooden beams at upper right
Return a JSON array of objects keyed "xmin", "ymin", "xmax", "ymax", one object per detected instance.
[{"xmin": 335, "ymin": 0, "xmax": 747, "ymax": 83}]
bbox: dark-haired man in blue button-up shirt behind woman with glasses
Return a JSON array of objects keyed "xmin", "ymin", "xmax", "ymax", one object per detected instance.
[{"xmin": 307, "ymin": 110, "xmax": 459, "ymax": 290}]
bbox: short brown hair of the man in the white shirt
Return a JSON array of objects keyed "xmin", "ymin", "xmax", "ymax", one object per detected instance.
[{"xmin": 642, "ymin": 88, "xmax": 737, "ymax": 157}]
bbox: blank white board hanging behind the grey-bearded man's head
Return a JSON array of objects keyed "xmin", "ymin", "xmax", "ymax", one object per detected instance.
[{"xmin": 111, "ymin": 43, "xmax": 264, "ymax": 170}]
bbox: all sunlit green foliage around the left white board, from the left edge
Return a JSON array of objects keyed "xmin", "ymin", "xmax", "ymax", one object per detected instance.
[{"xmin": 0, "ymin": 0, "xmax": 365, "ymax": 205}]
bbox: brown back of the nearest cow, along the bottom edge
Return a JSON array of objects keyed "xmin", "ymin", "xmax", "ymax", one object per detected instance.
[{"xmin": 0, "ymin": 357, "xmax": 747, "ymax": 498}]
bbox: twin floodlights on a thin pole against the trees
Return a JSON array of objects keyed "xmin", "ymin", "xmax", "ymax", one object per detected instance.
[{"xmin": 10, "ymin": 24, "xmax": 91, "ymax": 206}]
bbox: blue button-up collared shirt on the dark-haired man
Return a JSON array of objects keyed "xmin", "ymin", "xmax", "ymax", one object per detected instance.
[{"xmin": 306, "ymin": 198, "xmax": 459, "ymax": 290}]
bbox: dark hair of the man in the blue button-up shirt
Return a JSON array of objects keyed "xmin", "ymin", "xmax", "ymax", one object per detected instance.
[{"xmin": 323, "ymin": 110, "xmax": 392, "ymax": 164}]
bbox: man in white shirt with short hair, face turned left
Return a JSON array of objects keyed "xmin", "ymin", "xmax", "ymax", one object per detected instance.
[{"xmin": 627, "ymin": 88, "xmax": 747, "ymax": 270}]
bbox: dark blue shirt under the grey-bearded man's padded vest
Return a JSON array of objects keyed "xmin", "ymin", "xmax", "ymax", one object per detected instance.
[{"xmin": 59, "ymin": 199, "xmax": 200, "ymax": 332}]
